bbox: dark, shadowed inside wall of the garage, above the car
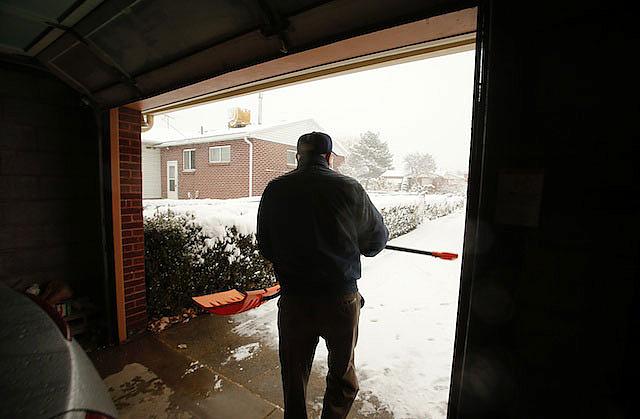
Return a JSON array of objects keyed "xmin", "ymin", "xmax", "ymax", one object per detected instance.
[{"xmin": 0, "ymin": 64, "xmax": 104, "ymax": 303}]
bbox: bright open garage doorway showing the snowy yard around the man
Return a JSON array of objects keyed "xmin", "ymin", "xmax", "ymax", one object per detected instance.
[{"xmin": 132, "ymin": 48, "xmax": 474, "ymax": 417}]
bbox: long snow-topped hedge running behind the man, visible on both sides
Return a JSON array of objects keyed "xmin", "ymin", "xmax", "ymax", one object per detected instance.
[{"xmin": 144, "ymin": 192, "xmax": 464, "ymax": 317}]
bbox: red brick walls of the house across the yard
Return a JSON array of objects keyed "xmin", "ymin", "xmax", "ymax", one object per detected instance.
[{"xmin": 160, "ymin": 139, "xmax": 344, "ymax": 199}]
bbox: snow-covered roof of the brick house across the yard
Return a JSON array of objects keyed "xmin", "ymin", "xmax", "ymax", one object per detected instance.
[{"xmin": 154, "ymin": 119, "xmax": 347, "ymax": 156}]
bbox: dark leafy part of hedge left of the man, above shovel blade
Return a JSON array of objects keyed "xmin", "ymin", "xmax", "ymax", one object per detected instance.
[{"xmin": 144, "ymin": 211, "xmax": 275, "ymax": 317}]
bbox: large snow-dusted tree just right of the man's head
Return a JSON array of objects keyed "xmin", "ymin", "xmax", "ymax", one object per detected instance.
[{"xmin": 344, "ymin": 131, "xmax": 393, "ymax": 188}]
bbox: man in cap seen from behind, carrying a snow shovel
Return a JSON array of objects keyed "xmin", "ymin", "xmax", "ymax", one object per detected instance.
[{"xmin": 257, "ymin": 132, "xmax": 389, "ymax": 419}]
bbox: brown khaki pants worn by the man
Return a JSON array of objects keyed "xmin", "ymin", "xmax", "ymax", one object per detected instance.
[{"xmin": 278, "ymin": 292, "xmax": 364, "ymax": 419}]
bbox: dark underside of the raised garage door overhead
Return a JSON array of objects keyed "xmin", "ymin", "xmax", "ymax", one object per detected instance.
[{"xmin": 0, "ymin": 0, "xmax": 474, "ymax": 108}]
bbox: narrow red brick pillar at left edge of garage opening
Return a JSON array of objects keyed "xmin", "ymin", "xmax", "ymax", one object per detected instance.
[{"xmin": 118, "ymin": 108, "xmax": 147, "ymax": 335}]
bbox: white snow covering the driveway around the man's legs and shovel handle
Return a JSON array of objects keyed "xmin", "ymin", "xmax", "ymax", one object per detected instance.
[{"xmin": 234, "ymin": 211, "xmax": 464, "ymax": 418}]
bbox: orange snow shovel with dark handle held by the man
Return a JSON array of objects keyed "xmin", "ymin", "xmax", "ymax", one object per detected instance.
[{"xmin": 191, "ymin": 245, "xmax": 458, "ymax": 316}]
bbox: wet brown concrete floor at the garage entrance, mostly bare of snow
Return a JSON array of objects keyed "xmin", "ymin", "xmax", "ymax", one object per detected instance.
[{"xmin": 91, "ymin": 315, "xmax": 393, "ymax": 419}]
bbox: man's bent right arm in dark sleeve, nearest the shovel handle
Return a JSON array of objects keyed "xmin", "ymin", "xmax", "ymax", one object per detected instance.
[{"xmin": 358, "ymin": 187, "xmax": 389, "ymax": 256}]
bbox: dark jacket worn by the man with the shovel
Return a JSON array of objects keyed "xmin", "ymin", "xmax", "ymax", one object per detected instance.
[{"xmin": 257, "ymin": 155, "xmax": 389, "ymax": 295}]
